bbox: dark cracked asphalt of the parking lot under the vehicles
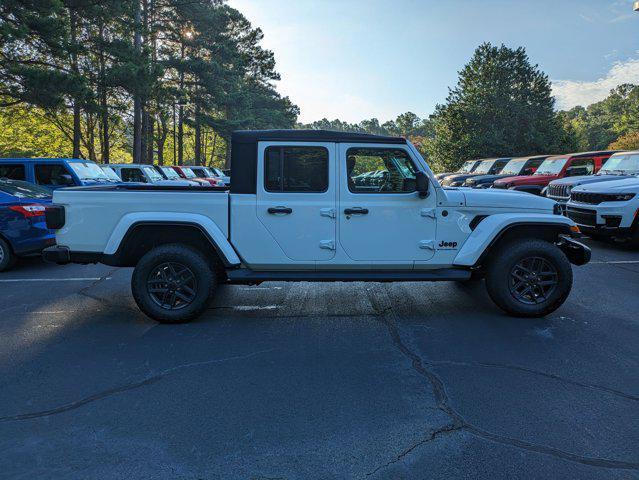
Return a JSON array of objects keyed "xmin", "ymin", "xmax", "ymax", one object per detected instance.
[{"xmin": 0, "ymin": 242, "xmax": 639, "ymax": 479}]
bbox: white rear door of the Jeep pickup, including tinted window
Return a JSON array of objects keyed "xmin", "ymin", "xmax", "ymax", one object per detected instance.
[{"xmin": 256, "ymin": 142, "xmax": 337, "ymax": 261}]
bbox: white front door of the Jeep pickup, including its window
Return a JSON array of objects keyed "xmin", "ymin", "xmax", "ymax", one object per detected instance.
[{"xmin": 338, "ymin": 144, "xmax": 437, "ymax": 266}]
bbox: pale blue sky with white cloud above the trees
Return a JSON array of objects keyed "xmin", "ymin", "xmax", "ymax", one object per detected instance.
[{"xmin": 228, "ymin": 0, "xmax": 639, "ymax": 123}]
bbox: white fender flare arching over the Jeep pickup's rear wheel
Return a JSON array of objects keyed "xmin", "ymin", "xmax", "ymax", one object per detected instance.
[{"xmin": 104, "ymin": 212, "xmax": 241, "ymax": 267}]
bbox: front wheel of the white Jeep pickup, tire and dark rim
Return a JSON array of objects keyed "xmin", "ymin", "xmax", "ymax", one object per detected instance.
[{"xmin": 486, "ymin": 240, "xmax": 572, "ymax": 317}]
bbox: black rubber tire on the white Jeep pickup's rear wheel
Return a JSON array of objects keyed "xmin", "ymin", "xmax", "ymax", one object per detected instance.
[{"xmin": 131, "ymin": 244, "xmax": 217, "ymax": 324}]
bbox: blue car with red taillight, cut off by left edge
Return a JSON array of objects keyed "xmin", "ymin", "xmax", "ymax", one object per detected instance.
[{"xmin": 0, "ymin": 179, "xmax": 55, "ymax": 272}]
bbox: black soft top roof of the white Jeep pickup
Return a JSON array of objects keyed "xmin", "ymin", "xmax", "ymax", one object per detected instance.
[{"xmin": 231, "ymin": 130, "xmax": 406, "ymax": 194}]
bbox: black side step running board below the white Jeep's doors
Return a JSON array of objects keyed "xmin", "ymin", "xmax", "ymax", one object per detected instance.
[{"xmin": 227, "ymin": 268, "xmax": 471, "ymax": 284}]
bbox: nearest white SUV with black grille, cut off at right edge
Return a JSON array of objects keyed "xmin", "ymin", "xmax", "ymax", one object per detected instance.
[{"xmin": 566, "ymin": 178, "xmax": 639, "ymax": 246}]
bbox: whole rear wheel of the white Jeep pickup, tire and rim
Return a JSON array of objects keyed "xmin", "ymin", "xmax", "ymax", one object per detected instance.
[{"xmin": 131, "ymin": 244, "xmax": 217, "ymax": 323}]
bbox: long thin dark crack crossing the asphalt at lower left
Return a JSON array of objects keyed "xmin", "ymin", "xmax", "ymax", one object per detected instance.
[{"xmin": 0, "ymin": 349, "xmax": 274, "ymax": 422}]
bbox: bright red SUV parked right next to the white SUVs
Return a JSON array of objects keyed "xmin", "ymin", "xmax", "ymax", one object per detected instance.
[{"xmin": 493, "ymin": 150, "xmax": 616, "ymax": 195}]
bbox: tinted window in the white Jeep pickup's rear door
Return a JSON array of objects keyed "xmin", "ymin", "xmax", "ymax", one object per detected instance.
[{"xmin": 264, "ymin": 147, "xmax": 328, "ymax": 193}]
